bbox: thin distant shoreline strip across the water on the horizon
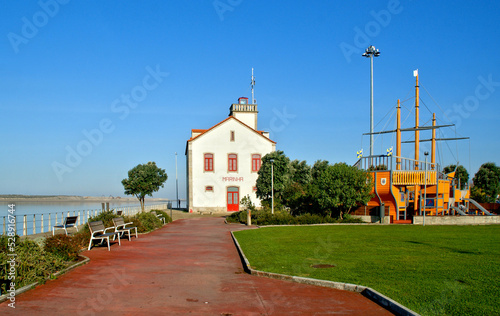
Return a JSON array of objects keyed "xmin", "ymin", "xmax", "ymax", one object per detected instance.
[{"xmin": 0, "ymin": 194, "xmax": 169, "ymax": 202}]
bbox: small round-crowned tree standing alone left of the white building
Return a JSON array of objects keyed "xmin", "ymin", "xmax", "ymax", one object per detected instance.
[{"xmin": 122, "ymin": 162, "xmax": 168, "ymax": 211}]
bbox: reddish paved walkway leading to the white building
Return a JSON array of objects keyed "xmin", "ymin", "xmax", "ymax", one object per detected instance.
[{"xmin": 0, "ymin": 218, "xmax": 391, "ymax": 316}]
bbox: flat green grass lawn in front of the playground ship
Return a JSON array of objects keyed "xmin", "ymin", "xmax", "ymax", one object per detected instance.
[{"xmin": 235, "ymin": 225, "xmax": 500, "ymax": 315}]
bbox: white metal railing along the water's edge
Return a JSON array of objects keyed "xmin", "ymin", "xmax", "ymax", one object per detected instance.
[{"xmin": 0, "ymin": 203, "xmax": 170, "ymax": 236}]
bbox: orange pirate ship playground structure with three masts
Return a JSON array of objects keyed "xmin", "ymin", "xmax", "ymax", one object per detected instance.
[{"xmin": 354, "ymin": 71, "xmax": 498, "ymax": 225}]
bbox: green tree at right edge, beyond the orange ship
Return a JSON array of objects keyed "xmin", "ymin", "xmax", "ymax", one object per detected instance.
[{"xmin": 471, "ymin": 162, "xmax": 500, "ymax": 203}]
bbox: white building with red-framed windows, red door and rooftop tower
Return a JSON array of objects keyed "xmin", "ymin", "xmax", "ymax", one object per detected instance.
[{"xmin": 186, "ymin": 98, "xmax": 276, "ymax": 212}]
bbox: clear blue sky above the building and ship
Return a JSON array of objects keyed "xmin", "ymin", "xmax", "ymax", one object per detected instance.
[{"xmin": 0, "ymin": 0, "xmax": 500, "ymax": 198}]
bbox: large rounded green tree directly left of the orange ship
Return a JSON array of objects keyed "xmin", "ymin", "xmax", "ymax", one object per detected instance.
[{"xmin": 312, "ymin": 162, "xmax": 372, "ymax": 219}]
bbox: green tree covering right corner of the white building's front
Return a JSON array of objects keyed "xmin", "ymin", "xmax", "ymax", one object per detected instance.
[{"xmin": 256, "ymin": 150, "xmax": 290, "ymax": 199}]
